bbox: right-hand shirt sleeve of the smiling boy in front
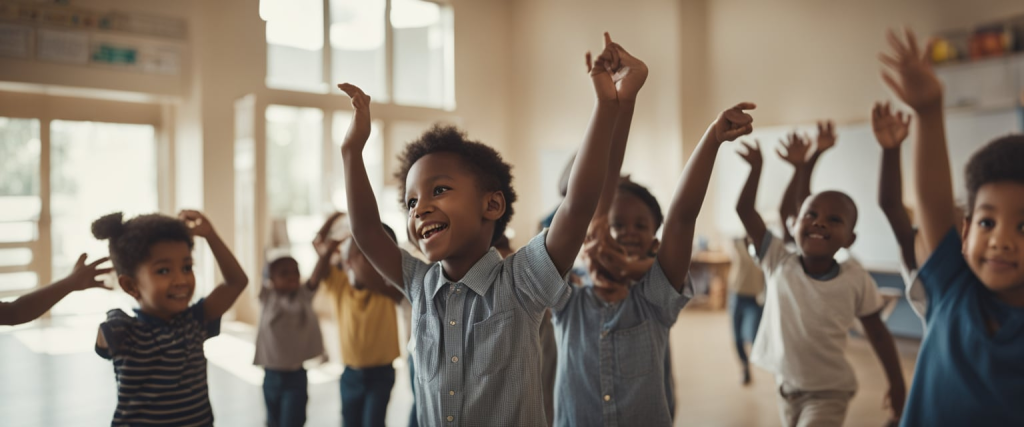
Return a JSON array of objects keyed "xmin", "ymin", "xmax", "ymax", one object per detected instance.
[{"xmin": 508, "ymin": 229, "xmax": 572, "ymax": 313}]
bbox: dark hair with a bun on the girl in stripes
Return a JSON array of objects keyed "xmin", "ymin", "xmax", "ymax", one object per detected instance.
[{"xmin": 92, "ymin": 212, "xmax": 195, "ymax": 276}]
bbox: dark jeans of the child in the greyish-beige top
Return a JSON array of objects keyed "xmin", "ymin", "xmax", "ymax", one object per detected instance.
[{"xmin": 263, "ymin": 369, "xmax": 308, "ymax": 427}]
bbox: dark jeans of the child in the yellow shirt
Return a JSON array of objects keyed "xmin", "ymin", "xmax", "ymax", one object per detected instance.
[{"xmin": 341, "ymin": 365, "xmax": 394, "ymax": 427}]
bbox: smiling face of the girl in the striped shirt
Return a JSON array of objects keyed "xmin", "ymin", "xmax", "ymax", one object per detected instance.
[{"xmin": 118, "ymin": 242, "xmax": 196, "ymax": 319}]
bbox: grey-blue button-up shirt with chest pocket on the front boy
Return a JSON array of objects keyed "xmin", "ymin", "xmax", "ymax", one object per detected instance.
[{"xmin": 400, "ymin": 231, "xmax": 572, "ymax": 426}]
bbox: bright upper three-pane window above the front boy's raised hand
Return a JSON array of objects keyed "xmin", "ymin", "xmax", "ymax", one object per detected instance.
[{"xmin": 260, "ymin": 0, "xmax": 455, "ymax": 110}]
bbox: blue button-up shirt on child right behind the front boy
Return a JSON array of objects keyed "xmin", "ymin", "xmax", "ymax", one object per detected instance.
[{"xmin": 552, "ymin": 262, "xmax": 693, "ymax": 427}]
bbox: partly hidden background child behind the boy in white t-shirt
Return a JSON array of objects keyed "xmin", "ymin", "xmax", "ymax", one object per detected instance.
[{"xmin": 729, "ymin": 234, "xmax": 765, "ymax": 385}]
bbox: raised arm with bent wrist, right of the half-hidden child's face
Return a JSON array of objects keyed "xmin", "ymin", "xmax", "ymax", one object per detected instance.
[{"xmin": 657, "ymin": 102, "xmax": 756, "ymax": 291}]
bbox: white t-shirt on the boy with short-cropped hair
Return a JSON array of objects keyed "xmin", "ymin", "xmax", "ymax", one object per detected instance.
[{"xmin": 751, "ymin": 236, "xmax": 883, "ymax": 391}]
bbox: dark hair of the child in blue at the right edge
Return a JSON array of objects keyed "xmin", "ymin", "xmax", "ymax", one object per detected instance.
[{"xmin": 964, "ymin": 133, "xmax": 1024, "ymax": 217}]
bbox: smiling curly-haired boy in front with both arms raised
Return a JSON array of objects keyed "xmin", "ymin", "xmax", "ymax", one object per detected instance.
[{"xmin": 339, "ymin": 32, "xmax": 621, "ymax": 426}]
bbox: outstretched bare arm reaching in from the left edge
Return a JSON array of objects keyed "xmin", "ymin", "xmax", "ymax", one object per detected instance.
[{"xmin": 0, "ymin": 254, "xmax": 112, "ymax": 326}]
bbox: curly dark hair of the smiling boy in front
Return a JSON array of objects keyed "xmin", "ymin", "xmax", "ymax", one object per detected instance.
[{"xmin": 394, "ymin": 124, "xmax": 516, "ymax": 244}]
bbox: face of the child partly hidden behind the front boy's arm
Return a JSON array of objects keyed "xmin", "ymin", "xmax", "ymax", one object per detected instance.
[{"xmin": 608, "ymin": 191, "xmax": 657, "ymax": 257}]
